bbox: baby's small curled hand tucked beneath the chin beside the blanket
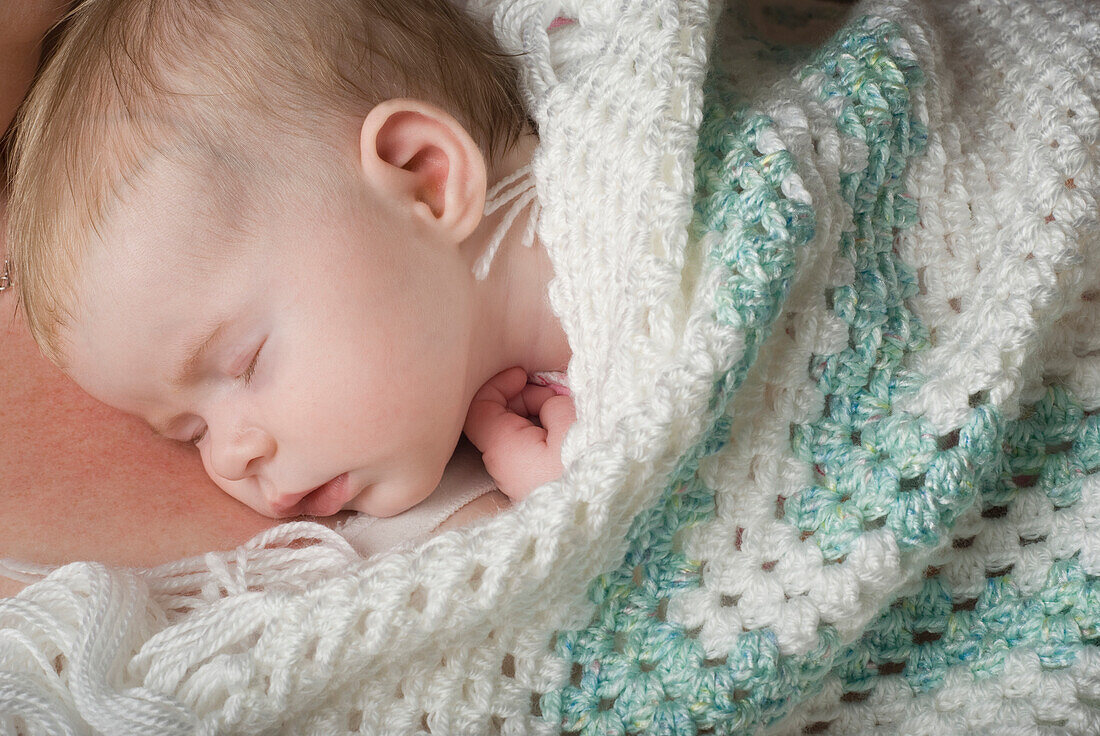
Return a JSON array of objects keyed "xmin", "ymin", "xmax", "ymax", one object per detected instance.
[{"xmin": 463, "ymin": 367, "xmax": 576, "ymax": 501}]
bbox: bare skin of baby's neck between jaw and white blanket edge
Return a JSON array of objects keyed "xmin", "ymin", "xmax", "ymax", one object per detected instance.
[{"xmin": 473, "ymin": 135, "xmax": 571, "ymax": 387}]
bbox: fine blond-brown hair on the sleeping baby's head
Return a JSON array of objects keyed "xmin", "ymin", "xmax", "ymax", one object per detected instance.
[{"xmin": 9, "ymin": 0, "xmax": 526, "ymax": 363}]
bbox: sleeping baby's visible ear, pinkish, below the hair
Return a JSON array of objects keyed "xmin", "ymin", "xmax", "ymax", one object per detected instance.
[{"xmin": 360, "ymin": 98, "xmax": 486, "ymax": 242}]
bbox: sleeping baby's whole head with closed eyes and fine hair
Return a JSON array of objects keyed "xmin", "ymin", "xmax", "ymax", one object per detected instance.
[{"xmin": 10, "ymin": 0, "xmax": 539, "ymax": 516}]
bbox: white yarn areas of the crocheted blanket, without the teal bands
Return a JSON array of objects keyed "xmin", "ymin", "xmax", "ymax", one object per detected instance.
[{"xmin": 0, "ymin": 0, "xmax": 1100, "ymax": 736}]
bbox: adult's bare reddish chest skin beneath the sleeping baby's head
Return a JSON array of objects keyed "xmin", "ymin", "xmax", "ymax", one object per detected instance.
[{"xmin": 0, "ymin": 0, "xmax": 507, "ymax": 596}]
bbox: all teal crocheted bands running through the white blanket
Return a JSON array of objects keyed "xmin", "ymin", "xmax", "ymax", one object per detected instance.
[{"xmin": 540, "ymin": 4, "xmax": 1100, "ymax": 736}]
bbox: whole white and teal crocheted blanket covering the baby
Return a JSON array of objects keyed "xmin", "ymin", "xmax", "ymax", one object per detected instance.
[{"xmin": 0, "ymin": 0, "xmax": 1100, "ymax": 736}]
